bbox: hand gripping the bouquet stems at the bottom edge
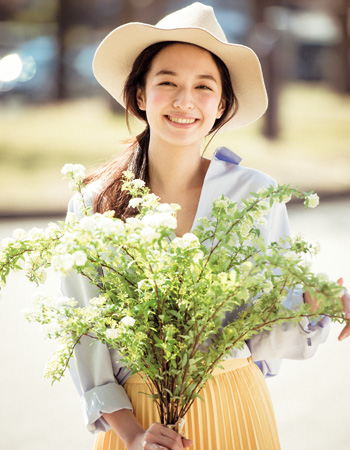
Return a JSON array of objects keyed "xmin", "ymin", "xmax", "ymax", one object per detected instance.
[{"xmin": 130, "ymin": 423, "xmax": 193, "ymax": 450}]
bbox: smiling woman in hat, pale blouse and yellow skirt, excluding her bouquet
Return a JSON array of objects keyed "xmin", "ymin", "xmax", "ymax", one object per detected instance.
[{"xmin": 63, "ymin": 3, "xmax": 350, "ymax": 450}]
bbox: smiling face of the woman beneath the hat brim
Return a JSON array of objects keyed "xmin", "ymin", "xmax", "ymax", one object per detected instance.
[{"xmin": 137, "ymin": 43, "xmax": 225, "ymax": 152}]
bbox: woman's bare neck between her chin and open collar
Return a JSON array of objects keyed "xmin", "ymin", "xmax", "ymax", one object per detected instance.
[{"xmin": 149, "ymin": 143, "xmax": 209, "ymax": 198}]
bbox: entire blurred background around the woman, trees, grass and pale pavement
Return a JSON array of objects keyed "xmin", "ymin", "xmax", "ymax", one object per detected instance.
[{"xmin": 0, "ymin": 0, "xmax": 350, "ymax": 450}]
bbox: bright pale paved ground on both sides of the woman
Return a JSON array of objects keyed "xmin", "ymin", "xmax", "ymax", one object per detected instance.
[{"xmin": 0, "ymin": 200, "xmax": 350, "ymax": 450}]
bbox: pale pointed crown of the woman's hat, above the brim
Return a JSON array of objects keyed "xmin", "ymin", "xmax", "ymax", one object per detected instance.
[{"xmin": 156, "ymin": 2, "xmax": 227, "ymax": 43}]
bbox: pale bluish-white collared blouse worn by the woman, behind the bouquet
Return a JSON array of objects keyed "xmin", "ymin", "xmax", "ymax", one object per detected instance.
[{"xmin": 61, "ymin": 147, "xmax": 330, "ymax": 432}]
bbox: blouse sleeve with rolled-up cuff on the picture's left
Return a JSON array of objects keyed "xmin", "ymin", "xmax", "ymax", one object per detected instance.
[{"xmin": 61, "ymin": 188, "xmax": 132, "ymax": 433}]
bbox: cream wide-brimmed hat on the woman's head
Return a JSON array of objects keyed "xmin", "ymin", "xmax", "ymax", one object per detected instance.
[{"xmin": 93, "ymin": 2, "xmax": 267, "ymax": 131}]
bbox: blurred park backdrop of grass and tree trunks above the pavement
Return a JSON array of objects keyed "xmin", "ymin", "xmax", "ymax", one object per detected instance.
[{"xmin": 0, "ymin": 0, "xmax": 350, "ymax": 217}]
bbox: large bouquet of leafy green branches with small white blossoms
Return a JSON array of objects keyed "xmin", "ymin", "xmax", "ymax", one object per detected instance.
[{"xmin": 0, "ymin": 165, "xmax": 345, "ymax": 432}]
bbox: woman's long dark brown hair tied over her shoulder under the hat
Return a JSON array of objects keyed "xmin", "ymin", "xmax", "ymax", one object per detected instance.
[{"xmin": 84, "ymin": 41, "xmax": 238, "ymax": 219}]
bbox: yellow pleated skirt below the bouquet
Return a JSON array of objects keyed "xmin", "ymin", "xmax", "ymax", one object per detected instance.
[{"xmin": 94, "ymin": 358, "xmax": 280, "ymax": 450}]
